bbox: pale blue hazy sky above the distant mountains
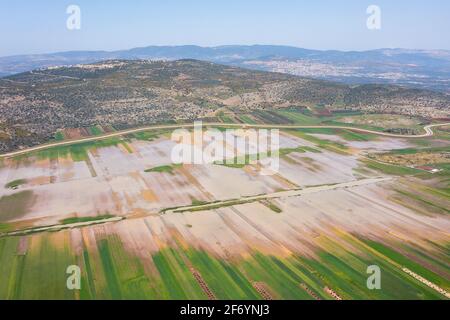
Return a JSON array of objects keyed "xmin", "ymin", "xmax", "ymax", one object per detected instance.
[{"xmin": 0, "ymin": 0, "xmax": 450, "ymax": 56}]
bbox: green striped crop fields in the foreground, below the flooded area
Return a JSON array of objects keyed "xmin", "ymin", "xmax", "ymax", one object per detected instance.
[{"xmin": 0, "ymin": 231, "xmax": 450, "ymax": 299}]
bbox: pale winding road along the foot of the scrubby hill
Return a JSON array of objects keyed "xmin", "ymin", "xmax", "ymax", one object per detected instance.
[{"xmin": 0, "ymin": 122, "xmax": 450, "ymax": 159}]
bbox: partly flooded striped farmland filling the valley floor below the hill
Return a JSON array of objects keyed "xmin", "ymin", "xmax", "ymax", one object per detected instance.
[{"xmin": 0, "ymin": 117, "xmax": 450, "ymax": 300}]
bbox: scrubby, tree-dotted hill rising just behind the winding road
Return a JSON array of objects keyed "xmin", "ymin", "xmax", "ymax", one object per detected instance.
[{"xmin": 0, "ymin": 60, "xmax": 450, "ymax": 151}]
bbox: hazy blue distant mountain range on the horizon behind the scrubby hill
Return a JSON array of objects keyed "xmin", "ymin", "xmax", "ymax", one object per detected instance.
[{"xmin": 0, "ymin": 45, "xmax": 450, "ymax": 93}]
